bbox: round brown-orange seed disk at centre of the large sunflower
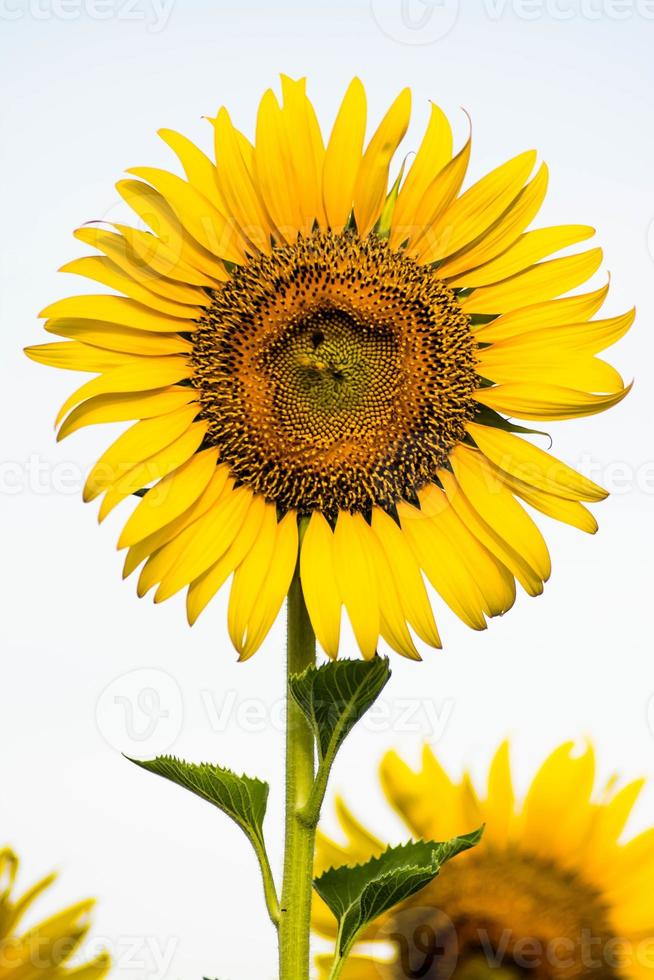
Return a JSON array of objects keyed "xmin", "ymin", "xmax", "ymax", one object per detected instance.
[{"xmin": 193, "ymin": 232, "xmax": 477, "ymax": 520}]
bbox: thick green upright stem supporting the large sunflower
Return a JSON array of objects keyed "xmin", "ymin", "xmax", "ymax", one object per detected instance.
[{"xmin": 279, "ymin": 568, "xmax": 316, "ymax": 980}]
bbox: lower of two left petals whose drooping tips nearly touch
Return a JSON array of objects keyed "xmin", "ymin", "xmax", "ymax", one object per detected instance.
[{"xmin": 57, "ymin": 386, "xmax": 197, "ymax": 441}]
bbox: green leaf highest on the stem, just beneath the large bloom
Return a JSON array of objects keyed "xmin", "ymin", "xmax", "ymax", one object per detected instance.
[{"xmin": 289, "ymin": 656, "xmax": 391, "ymax": 761}]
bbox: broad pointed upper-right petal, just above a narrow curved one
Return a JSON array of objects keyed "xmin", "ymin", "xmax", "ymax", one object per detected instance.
[{"xmin": 420, "ymin": 150, "xmax": 536, "ymax": 263}]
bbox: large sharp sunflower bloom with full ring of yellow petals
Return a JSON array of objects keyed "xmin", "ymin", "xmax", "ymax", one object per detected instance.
[{"xmin": 27, "ymin": 77, "xmax": 633, "ymax": 659}]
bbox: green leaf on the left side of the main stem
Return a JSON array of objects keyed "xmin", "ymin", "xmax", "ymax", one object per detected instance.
[{"xmin": 130, "ymin": 755, "xmax": 269, "ymax": 847}]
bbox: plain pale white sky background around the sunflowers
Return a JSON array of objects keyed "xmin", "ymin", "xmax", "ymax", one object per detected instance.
[{"xmin": 0, "ymin": 0, "xmax": 654, "ymax": 980}]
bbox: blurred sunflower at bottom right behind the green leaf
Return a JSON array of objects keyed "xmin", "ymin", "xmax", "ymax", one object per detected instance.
[{"xmin": 314, "ymin": 743, "xmax": 654, "ymax": 980}]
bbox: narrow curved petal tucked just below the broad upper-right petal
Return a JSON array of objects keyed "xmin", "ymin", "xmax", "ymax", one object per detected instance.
[{"xmin": 438, "ymin": 163, "xmax": 548, "ymax": 278}]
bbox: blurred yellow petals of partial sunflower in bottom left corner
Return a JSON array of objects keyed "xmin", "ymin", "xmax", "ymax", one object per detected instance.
[{"xmin": 0, "ymin": 847, "xmax": 111, "ymax": 980}]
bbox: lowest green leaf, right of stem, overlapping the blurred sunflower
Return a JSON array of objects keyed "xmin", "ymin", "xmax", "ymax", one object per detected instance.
[{"xmin": 314, "ymin": 828, "xmax": 483, "ymax": 959}]
